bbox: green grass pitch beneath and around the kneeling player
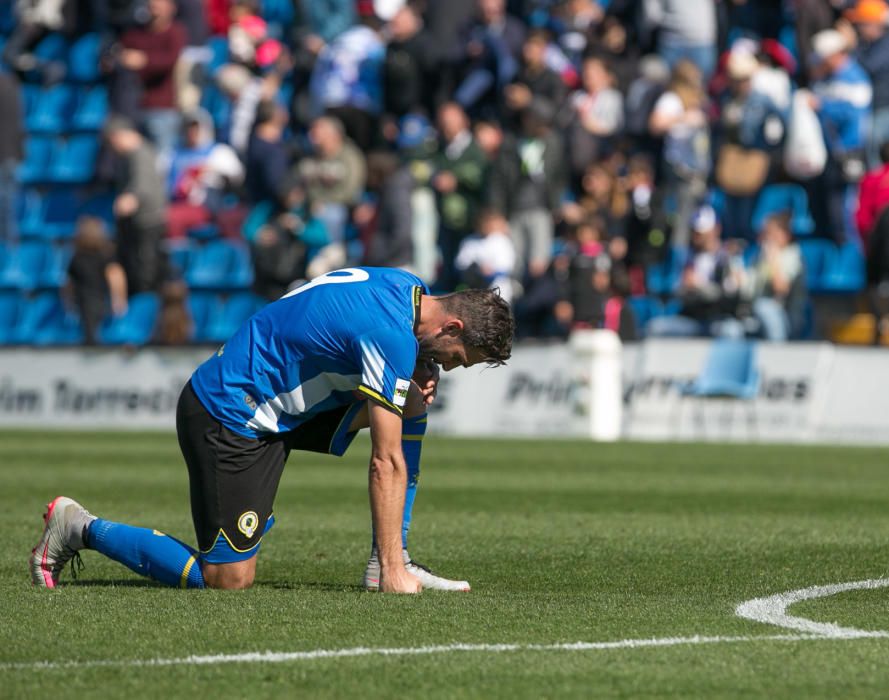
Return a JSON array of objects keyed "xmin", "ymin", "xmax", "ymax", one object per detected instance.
[{"xmin": 0, "ymin": 432, "xmax": 889, "ymax": 699}]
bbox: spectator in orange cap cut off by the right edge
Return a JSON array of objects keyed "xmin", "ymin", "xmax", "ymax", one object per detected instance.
[{"xmin": 846, "ymin": 0, "xmax": 889, "ymax": 168}]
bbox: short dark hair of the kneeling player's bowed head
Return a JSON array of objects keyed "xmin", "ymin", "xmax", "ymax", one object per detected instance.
[{"xmin": 438, "ymin": 289, "xmax": 515, "ymax": 365}]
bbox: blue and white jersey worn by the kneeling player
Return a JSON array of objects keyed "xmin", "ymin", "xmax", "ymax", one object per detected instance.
[{"xmin": 191, "ymin": 267, "xmax": 429, "ymax": 437}]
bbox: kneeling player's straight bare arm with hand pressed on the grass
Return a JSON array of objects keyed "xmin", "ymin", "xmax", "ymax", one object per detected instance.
[{"xmin": 368, "ymin": 403, "xmax": 422, "ymax": 593}]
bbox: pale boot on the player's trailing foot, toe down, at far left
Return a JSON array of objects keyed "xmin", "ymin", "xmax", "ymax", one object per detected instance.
[{"xmin": 28, "ymin": 496, "xmax": 96, "ymax": 588}]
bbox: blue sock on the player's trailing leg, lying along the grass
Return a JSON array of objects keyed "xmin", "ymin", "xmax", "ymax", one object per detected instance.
[{"xmin": 87, "ymin": 518, "xmax": 204, "ymax": 588}]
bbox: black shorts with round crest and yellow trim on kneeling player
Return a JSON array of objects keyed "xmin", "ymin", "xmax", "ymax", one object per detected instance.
[{"xmin": 176, "ymin": 382, "xmax": 362, "ymax": 564}]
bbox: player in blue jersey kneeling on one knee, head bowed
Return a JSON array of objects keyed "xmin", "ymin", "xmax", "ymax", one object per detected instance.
[{"xmin": 30, "ymin": 268, "xmax": 514, "ymax": 593}]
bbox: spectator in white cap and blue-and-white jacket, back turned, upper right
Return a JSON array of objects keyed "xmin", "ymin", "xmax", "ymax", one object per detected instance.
[{"xmin": 809, "ymin": 29, "xmax": 873, "ymax": 243}]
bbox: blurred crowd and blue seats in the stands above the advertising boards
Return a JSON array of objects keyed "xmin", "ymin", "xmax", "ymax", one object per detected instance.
[{"xmin": 0, "ymin": 0, "xmax": 889, "ymax": 344}]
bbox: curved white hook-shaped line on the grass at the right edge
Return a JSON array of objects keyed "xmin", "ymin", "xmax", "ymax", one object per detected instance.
[{"xmin": 735, "ymin": 578, "xmax": 889, "ymax": 639}]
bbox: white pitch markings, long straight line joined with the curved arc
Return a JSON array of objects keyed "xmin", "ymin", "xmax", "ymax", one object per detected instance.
[{"xmin": 0, "ymin": 579, "xmax": 889, "ymax": 671}]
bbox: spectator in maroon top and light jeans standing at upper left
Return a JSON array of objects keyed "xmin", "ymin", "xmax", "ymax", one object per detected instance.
[{"xmin": 117, "ymin": 0, "xmax": 186, "ymax": 167}]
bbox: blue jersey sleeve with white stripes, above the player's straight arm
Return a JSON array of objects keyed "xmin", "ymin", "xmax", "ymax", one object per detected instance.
[{"xmin": 358, "ymin": 328, "xmax": 417, "ymax": 415}]
